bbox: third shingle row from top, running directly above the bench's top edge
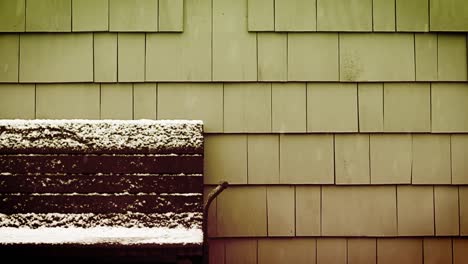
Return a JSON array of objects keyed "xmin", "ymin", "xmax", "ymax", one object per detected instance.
[{"xmin": 0, "ymin": 82, "xmax": 468, "ymax": 133}]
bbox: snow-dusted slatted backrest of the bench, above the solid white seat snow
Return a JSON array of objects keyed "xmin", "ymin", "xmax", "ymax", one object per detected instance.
[{"xmin": 0, "ymin": 120, "xmax": 203, "ymax": 228}]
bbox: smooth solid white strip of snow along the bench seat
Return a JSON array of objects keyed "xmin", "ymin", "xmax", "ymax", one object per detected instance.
[{"xmin": 0, "ymin": 227, "xmax": 203, "ymax": 245}]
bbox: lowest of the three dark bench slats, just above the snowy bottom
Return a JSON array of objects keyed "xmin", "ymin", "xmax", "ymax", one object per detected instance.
[{"xmin": 0, "ymin": 194, "xmax": 203, "ymax": 214}]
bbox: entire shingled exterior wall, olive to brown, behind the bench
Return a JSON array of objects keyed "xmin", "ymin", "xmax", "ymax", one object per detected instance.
[{"xmin": 0, "ymin": 0, "xmax": 468, "ymax": 264}]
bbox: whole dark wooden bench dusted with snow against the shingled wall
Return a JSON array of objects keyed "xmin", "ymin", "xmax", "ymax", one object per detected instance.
[{"xmin": 0, "ymin": 120, "xmax": 226, "ymax": 263}]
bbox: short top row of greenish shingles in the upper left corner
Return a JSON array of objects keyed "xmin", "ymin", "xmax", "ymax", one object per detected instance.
[{"xmin": 0, "ymin": 0, "xmax": 183, "ymax": 32}]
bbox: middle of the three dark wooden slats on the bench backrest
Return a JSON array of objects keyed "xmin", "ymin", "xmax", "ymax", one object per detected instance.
[{"xmin": 0, "ymin": 174, "xmax": 203, "ymax": 193}]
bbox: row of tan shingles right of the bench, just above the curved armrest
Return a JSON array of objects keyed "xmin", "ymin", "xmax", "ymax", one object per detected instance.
[{"xmin": 205, "ymin": 134, "xmax": 468, "ymax": 185}]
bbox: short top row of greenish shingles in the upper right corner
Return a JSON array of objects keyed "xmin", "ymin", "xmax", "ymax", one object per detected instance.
[{"xmin": 248, "ymin": 0, "xmax": 468, "ymax": 32}]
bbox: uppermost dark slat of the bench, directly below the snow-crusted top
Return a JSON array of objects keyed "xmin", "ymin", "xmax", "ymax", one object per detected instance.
[{"xmin": 0, "ymin": 155, "xmax": 203, "ymax": 174}]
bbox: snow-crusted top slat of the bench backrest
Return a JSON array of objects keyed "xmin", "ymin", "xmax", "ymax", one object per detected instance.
[{"xmin": 0, "ymin": 119, "xmax": 203, "ymax": 153}]
